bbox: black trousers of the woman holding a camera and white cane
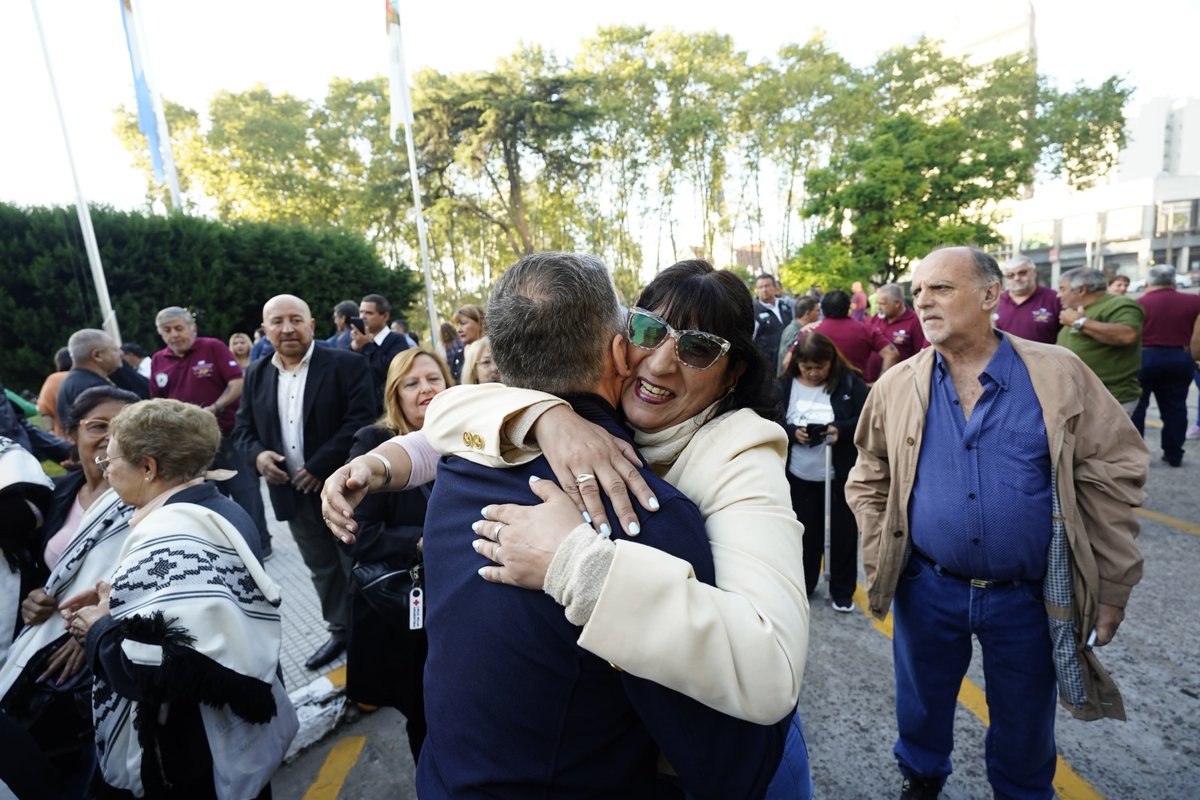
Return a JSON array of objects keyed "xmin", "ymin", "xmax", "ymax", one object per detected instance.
[{"xmin": 787, "ymin": 473, "xmax": 858, "ymax": 606}]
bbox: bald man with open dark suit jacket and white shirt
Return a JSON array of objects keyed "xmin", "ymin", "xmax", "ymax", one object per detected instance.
[{"xmin": 233, "ymin": 295, "xmax": 374, "ymax": 669}]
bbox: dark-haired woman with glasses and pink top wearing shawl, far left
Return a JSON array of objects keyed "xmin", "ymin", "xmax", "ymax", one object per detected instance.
[{"xmin": 0, "ymin": 386, "xmax": 140, "ymax": 796}]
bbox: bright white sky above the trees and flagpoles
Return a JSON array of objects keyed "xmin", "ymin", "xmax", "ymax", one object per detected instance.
[{"xmin": 0, "ymin": 0, "xmax": 1200, "ymax": 209}]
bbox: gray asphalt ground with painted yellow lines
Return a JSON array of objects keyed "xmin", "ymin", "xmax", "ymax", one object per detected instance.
[{"xmin": 272, "ymin": 387, "xmax": 1200, "ymax": 800}]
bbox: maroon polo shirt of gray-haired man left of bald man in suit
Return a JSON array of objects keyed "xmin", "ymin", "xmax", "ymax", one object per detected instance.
[{"xmin": 150, "ymin": 336, "xmax": 242, "ymax": 431}]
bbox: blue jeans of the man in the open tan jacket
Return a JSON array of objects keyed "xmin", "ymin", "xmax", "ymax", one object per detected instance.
[{"xmin": 893, "ymin": 557, "xmax": 1057, "ymax": 799}]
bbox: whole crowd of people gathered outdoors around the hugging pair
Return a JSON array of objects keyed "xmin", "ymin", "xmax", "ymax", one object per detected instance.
[{"xmin": 0, "ymin": 247, "xmax": 1185, "ymax": 798}]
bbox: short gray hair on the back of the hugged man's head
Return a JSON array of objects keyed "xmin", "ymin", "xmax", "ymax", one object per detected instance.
[{"xmin": 487, "ymin": 253, "xmax": 623, "ymax": 395}]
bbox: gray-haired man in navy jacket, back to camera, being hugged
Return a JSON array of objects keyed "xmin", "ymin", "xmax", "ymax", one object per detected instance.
[{"xmin": 416, "ymin": 253, "xmax": 784, "ymax": 800}]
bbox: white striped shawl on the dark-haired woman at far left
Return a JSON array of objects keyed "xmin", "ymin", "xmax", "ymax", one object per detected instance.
[{"xmin": 0, "ymin": 489, "xmax": 133, "ymax": 697}]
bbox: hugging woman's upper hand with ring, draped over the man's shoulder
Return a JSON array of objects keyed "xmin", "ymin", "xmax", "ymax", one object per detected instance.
[{"xmin": 533, "ymin": 405, "xmax": 659, "ymax": 536}]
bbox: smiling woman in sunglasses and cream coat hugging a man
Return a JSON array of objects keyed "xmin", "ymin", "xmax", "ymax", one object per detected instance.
[{"xmin": 323, "ymin": 260, "xmax": 809, "ymax": 724}]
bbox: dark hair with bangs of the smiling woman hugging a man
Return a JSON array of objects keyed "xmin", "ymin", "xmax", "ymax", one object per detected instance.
[{"xmin": 637, "ymin": 259, "xmax": 775, "ymax": 420}]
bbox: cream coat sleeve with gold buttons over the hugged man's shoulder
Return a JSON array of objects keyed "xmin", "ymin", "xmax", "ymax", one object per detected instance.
[{"xmin": 421, "ymin": 384, "xmax": 566, "ymax": 467}]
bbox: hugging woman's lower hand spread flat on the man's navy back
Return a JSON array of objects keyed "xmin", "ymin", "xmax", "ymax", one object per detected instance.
[{"xmin": 470, "ymin": 476, "xmax": 581, "ymax": 589}]
